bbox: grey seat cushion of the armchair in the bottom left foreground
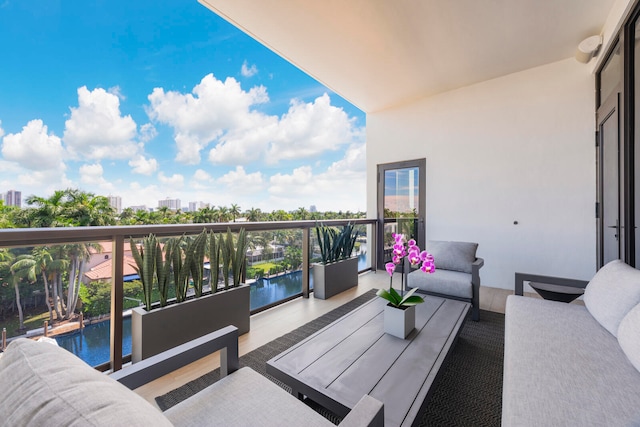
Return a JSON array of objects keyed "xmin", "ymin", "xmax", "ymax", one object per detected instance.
[{"xmin": 165, "ymin": 367, "xmax": 333, "ymax": 427}]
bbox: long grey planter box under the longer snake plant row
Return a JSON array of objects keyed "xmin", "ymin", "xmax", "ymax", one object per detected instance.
[{"xmin": 131, "ymin": 285, "xmax": 250, "ymax": 363}]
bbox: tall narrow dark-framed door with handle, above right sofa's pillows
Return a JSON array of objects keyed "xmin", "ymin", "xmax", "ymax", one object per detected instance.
[{"xmin": 598, "ymin": 92, "xmax": 624, "ymax": 267}]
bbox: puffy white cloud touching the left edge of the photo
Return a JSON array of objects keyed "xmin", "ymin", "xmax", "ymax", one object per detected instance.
[{"xmin": 2, "ymin": 119, "xmax": 65, "ymax": 171}]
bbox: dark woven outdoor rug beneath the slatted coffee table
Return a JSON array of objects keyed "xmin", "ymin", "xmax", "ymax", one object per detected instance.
[{"xmin": 156, "ymin": 290, "xmax": 504, "ymax": 426}]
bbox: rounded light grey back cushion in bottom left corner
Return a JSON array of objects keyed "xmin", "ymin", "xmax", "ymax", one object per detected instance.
[{"xmin": 0, "ymin": 338, "xmax": 171, "ymax": 427}]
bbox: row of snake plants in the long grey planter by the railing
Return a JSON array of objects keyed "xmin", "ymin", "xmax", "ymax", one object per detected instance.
[{"xmin": 131, "ymin": 229, "xmax": 250, "ymax": 363}]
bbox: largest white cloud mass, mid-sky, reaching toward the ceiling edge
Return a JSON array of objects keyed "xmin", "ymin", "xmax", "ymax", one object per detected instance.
[{"xmin": 147, "ymin": 73, "xmax": 364, "ymax": 166}]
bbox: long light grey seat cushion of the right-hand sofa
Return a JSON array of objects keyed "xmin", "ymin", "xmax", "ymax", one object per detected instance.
[{"xmin": 502, "ymin": 295, "xmax": 640, "ymax": 427}]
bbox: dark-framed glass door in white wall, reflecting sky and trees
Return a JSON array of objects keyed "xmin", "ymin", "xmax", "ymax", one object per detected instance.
[{"xmin": 376, "ymin": 159, "xmax": 426, "ymax": 270}]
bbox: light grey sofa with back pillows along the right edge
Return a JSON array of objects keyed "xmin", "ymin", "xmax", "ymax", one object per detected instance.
[{"xmin": 502, "ymin": 261, "xmax": 640, "ymax": 427}]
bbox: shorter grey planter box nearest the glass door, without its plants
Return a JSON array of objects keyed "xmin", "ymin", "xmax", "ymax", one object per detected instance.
[{"xmin": 311, "ymin": 257, "xmax": 358, "ymax": 299}]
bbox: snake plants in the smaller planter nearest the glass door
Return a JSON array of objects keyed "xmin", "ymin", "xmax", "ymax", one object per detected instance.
[{"xmin": 311, "ymin": 224, "xmax": 358, "ymax": 299}]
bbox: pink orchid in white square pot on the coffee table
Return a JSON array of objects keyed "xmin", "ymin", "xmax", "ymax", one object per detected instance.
[{"xmin": 376, "ymin": 233, "xmax": 436, "ymax": 339}]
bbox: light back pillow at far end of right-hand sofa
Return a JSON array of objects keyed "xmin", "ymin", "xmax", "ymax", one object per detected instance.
[{"xmin": 584, "ymin": 260, "xmax": 640, "ymax": 336}]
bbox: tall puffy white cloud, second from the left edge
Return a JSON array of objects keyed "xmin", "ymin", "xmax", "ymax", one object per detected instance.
[{"xmin": 63, "ymin": 86, "xmax": 138, "ymax": 160}]
